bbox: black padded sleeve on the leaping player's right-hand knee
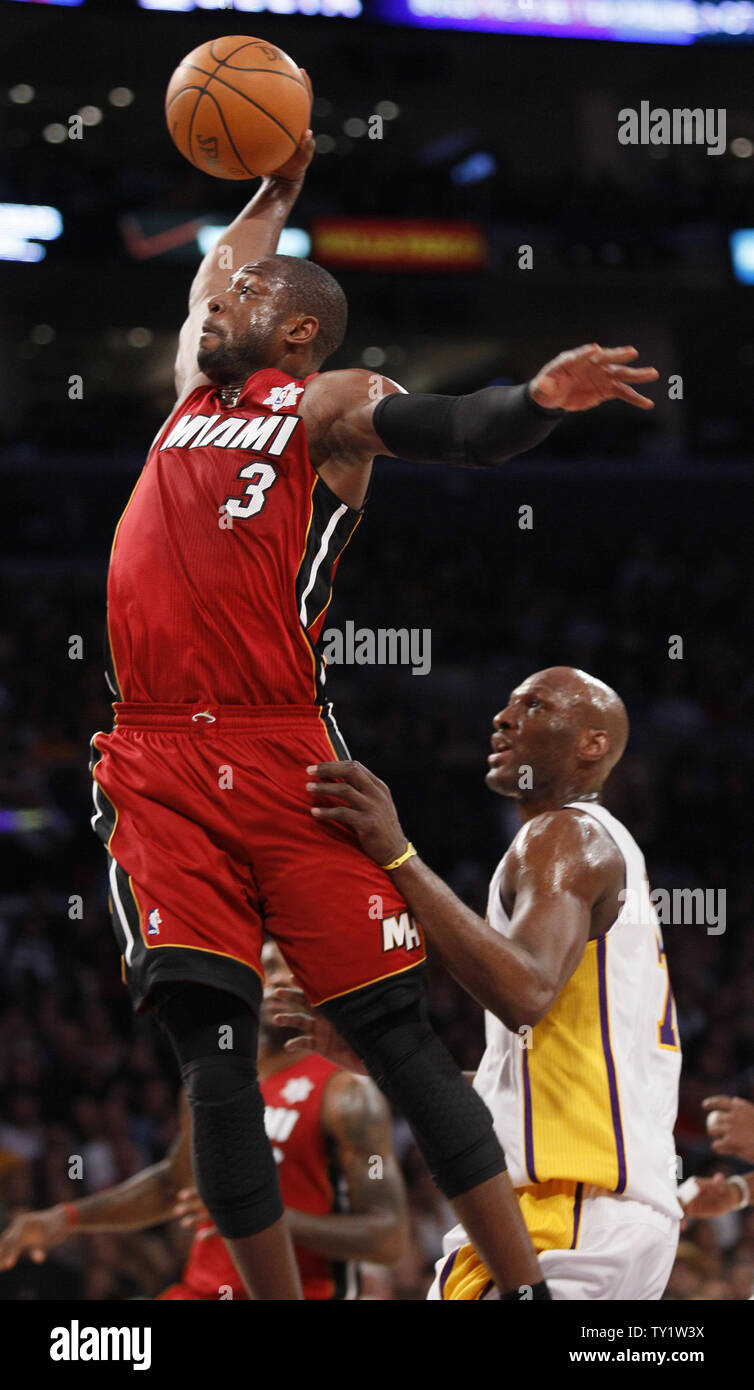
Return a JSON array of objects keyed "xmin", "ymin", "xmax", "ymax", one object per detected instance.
[{"xmin": 320, "ymin": 970, "xmax": 505, "ymax": 1198}]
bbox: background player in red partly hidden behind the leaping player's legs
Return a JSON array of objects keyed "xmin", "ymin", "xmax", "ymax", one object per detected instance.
[{"xmin": 0, "ymin": 941, "xmax": 406, "ymax": 1301}]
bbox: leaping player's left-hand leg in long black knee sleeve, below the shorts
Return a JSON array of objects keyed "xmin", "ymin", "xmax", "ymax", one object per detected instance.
[{"xmin": 154, "ymin": 984, "xmax": 302, "ymax": 1298}]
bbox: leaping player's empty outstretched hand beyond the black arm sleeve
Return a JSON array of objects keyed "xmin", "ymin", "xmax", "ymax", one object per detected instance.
[{"xmin": 529, "ymin": 343, "xmax": 659, "ymax": 410}]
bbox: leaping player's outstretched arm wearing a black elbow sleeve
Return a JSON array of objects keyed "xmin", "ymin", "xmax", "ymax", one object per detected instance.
[{"xmin": 306, "ymin": 343, "xmax": 658, "ymax": 483}]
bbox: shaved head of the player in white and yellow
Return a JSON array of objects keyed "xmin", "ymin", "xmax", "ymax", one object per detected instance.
[{"xmin": 487, "ymin": 666, "xmax": 629, "ymax": 805}]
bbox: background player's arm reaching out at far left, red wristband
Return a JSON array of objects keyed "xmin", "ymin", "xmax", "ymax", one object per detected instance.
[{"xmin": 0, "ymin": 1105, "xmax": 193, "ymax": 1270}]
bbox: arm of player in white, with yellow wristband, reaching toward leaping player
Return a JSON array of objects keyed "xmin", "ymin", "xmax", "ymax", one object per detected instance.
[{"xmin": 306, "ymin": 762, "xmax": 608, "ymax": 1031}]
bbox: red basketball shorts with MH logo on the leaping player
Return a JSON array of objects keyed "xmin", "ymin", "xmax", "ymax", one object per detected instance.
[{"xmin": 92, "ymin": 705, "xmax": 424, "ymax": 1009}]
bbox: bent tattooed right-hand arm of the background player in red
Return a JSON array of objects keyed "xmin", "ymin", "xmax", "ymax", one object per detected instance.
[{"xmin": 285, "ymin": 1072, "xmax": 408, "ymax": 1265}]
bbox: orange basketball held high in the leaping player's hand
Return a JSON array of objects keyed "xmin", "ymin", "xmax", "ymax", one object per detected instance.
[{"xmin": 166, "ymin": 35, "xmax": 310, "ymax": 179}]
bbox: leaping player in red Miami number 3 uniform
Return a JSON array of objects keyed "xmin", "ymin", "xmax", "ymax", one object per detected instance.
[{"xmin": 92, "ymin": 122, "xmax": 657, "ymax": 1300}]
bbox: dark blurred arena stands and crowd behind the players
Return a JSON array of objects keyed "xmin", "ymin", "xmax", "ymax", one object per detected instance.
[{"xmin": 0, "ymin": 0, "xmax": 754, "ymax": 1300}]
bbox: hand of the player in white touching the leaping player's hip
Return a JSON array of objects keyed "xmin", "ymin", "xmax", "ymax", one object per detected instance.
[{"xmin": 306, "ymin": 759, "xmax": 406, "ymax": 865}]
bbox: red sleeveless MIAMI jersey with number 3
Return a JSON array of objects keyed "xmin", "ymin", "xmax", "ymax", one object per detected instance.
[{"xmin": 107, "ymin": 368, "xmax": 362, "ymax": 706}]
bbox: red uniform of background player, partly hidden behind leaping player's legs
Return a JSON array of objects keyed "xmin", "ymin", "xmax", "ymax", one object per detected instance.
[{"xmin": 160, "ymin": 1054, "xmax": 358, "ymax": 1300}]
